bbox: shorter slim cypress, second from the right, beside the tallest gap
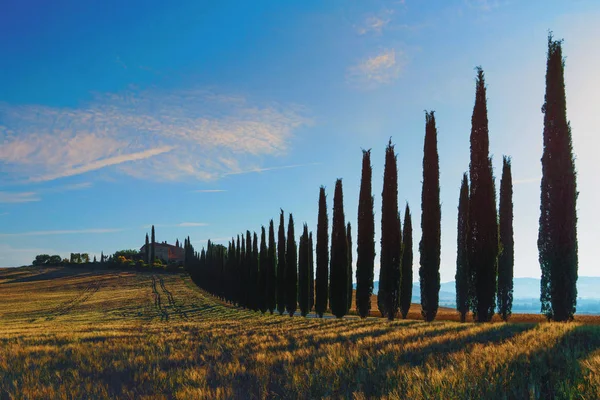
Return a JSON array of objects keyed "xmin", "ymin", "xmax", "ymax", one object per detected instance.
[{"xmin": 498, "ymin": 157, "xmax": 515, "ymax": 321}]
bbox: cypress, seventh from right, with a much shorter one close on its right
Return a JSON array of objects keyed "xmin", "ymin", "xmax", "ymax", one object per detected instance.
[{"xmin": 377, "ymin": 139, "xmax": 402, "ymax": 321}]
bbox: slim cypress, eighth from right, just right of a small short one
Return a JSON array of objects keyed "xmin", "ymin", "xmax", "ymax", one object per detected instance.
[{"xmin": 356, "ymin": 150, "xmax": 375, "ymax": 318}]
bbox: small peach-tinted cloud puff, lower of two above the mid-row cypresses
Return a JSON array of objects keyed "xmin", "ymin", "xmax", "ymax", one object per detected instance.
[{"xmin": 346, "ymin": 49, "xmax": 407, "ymax": 89}]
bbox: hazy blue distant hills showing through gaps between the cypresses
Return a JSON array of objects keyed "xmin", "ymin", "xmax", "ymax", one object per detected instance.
[{"xmin": 354, "ymin": 276, "xmax": 600, "ymax": 314}]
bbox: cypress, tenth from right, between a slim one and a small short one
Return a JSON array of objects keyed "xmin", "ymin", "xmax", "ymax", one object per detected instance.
[{"xmin": 329, "ymin": 179, "xmax": 348, "ymax": 318}]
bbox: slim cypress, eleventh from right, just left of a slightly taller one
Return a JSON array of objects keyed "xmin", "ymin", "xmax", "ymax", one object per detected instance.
[{"xmin": 315, "ymin": 186, "xmax": 329, "ymax": 317}]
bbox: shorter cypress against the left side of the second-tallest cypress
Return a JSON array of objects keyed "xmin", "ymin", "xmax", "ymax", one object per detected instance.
[{"xmin": 454, "ymin": 172, "xmax": 470, "ymax": 322}]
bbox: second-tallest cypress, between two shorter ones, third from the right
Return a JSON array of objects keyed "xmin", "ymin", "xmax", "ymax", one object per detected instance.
[{"xmin": 468, "ymin": 67, "xmax": 499, "ymax": 322}]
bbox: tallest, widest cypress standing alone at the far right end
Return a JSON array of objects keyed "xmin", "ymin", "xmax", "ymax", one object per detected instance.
[{"xmin": 538, "ymin": 34, "xmax": 578, "ymax": 321}]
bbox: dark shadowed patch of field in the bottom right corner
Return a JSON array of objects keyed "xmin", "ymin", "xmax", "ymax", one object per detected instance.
[{"xmin": 490, "ymin": 325, "xmax": 600, "ymax": 399}]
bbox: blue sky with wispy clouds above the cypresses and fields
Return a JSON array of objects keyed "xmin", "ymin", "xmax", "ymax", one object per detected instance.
[{"xmin": 0, "ymin": 0, "xmax": 600, "ymax": 281}]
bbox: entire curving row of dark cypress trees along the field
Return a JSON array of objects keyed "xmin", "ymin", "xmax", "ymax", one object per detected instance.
[{"xmin": 186, "ymin": 34, "xmax": 577, "ymax": 322}]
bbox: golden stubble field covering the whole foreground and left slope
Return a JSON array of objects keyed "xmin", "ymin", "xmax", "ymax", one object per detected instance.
[{"xmin": 0, "ymin": 267, "xmax": 600, "ymax": 399}]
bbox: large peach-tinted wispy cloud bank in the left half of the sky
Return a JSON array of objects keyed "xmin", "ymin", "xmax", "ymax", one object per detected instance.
[{"xmin": 0, "ymin": 89, "xmax": 310, "ymax": 182}]
